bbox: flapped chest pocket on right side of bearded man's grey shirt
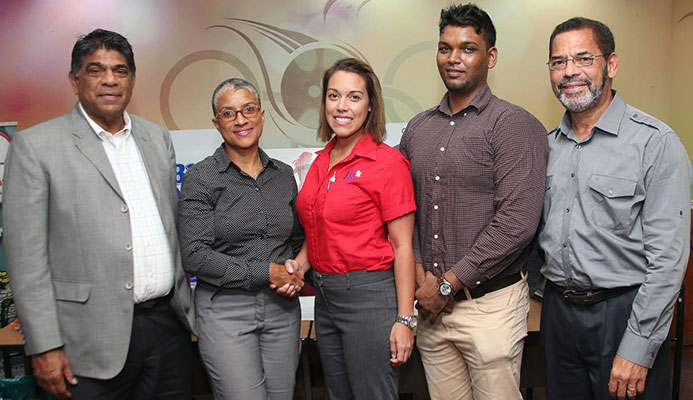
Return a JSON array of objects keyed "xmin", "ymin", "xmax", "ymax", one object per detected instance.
[{"xmin": 589, "ymin": 174, "xmax": 637, "ymax": 230}]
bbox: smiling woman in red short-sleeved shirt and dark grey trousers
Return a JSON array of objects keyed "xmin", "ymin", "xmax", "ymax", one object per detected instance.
[{"xmin": 287, "ymin": 59, "xmax": 416, "ymax": 400}]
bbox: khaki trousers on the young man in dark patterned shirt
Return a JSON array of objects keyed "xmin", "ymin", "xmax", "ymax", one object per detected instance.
[{"xmin": 416, "ymin": 278, "xmax": 529, "ymax": 400}]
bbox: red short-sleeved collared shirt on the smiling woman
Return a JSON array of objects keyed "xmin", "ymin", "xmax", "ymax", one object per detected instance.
[{"xmin": 296, "ymin": 134, "xmax": 416, "ymax": 274}]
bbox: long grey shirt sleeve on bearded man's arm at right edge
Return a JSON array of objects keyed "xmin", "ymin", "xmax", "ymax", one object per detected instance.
[{"xmin": 618, "ymin": 132, "xmax": 691, "ymax": 368}]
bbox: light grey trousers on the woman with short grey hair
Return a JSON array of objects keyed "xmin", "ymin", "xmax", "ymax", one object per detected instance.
[{"xmin": 195, "ymin": 282, "xmax": 301, "ymax": 400}]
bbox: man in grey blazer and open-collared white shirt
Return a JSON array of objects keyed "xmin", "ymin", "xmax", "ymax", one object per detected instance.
[{"xmin": 3, "ymin": 29, "xmax": 194, "ymax": 399}]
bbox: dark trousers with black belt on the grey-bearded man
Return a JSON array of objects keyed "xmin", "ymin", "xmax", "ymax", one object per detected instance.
[{"xmin": 541, "ymin": 285, "xmax": 671, "ymax": 400}]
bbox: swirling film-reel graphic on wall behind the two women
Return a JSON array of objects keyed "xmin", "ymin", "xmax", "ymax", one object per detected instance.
[{"xmin": 160, "ymin": 0, "xmax": 436, "ymax": 147}]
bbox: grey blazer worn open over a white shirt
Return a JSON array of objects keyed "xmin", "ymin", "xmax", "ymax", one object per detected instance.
[{"xmin": 3, "ymin": 106, "xmax": 194, "ymax": 379}]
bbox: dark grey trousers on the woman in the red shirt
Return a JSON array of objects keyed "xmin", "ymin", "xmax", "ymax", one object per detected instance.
[{"xmin": 313, "ymin": 268, "xmax": 398, "ymax": 400}]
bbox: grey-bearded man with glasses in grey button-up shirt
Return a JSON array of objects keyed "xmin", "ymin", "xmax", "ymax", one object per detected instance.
[{"xmin": 539, "ymin": 18, "xmax": 691, "ymax": 399}]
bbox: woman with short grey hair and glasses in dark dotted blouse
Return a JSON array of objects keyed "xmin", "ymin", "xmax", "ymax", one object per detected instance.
[{"xmin": 178, "ymin": 79, "xmax": 304, "ymax": 400}]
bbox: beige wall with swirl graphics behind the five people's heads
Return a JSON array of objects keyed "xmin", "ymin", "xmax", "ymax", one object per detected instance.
[{"xmin": 0, "ymin": 0, "xmax": 693, "ymax": 157}]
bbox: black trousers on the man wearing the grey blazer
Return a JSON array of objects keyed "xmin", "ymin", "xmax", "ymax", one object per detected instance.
[{"xmin": 68, "ymin": 298, "xmax": 193, "ymax": 400}]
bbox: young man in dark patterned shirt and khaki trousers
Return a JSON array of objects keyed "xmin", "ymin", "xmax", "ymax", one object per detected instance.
[{"xmin": 401, "ymin": 4, "xmax": 548, "ymax": 400}]
